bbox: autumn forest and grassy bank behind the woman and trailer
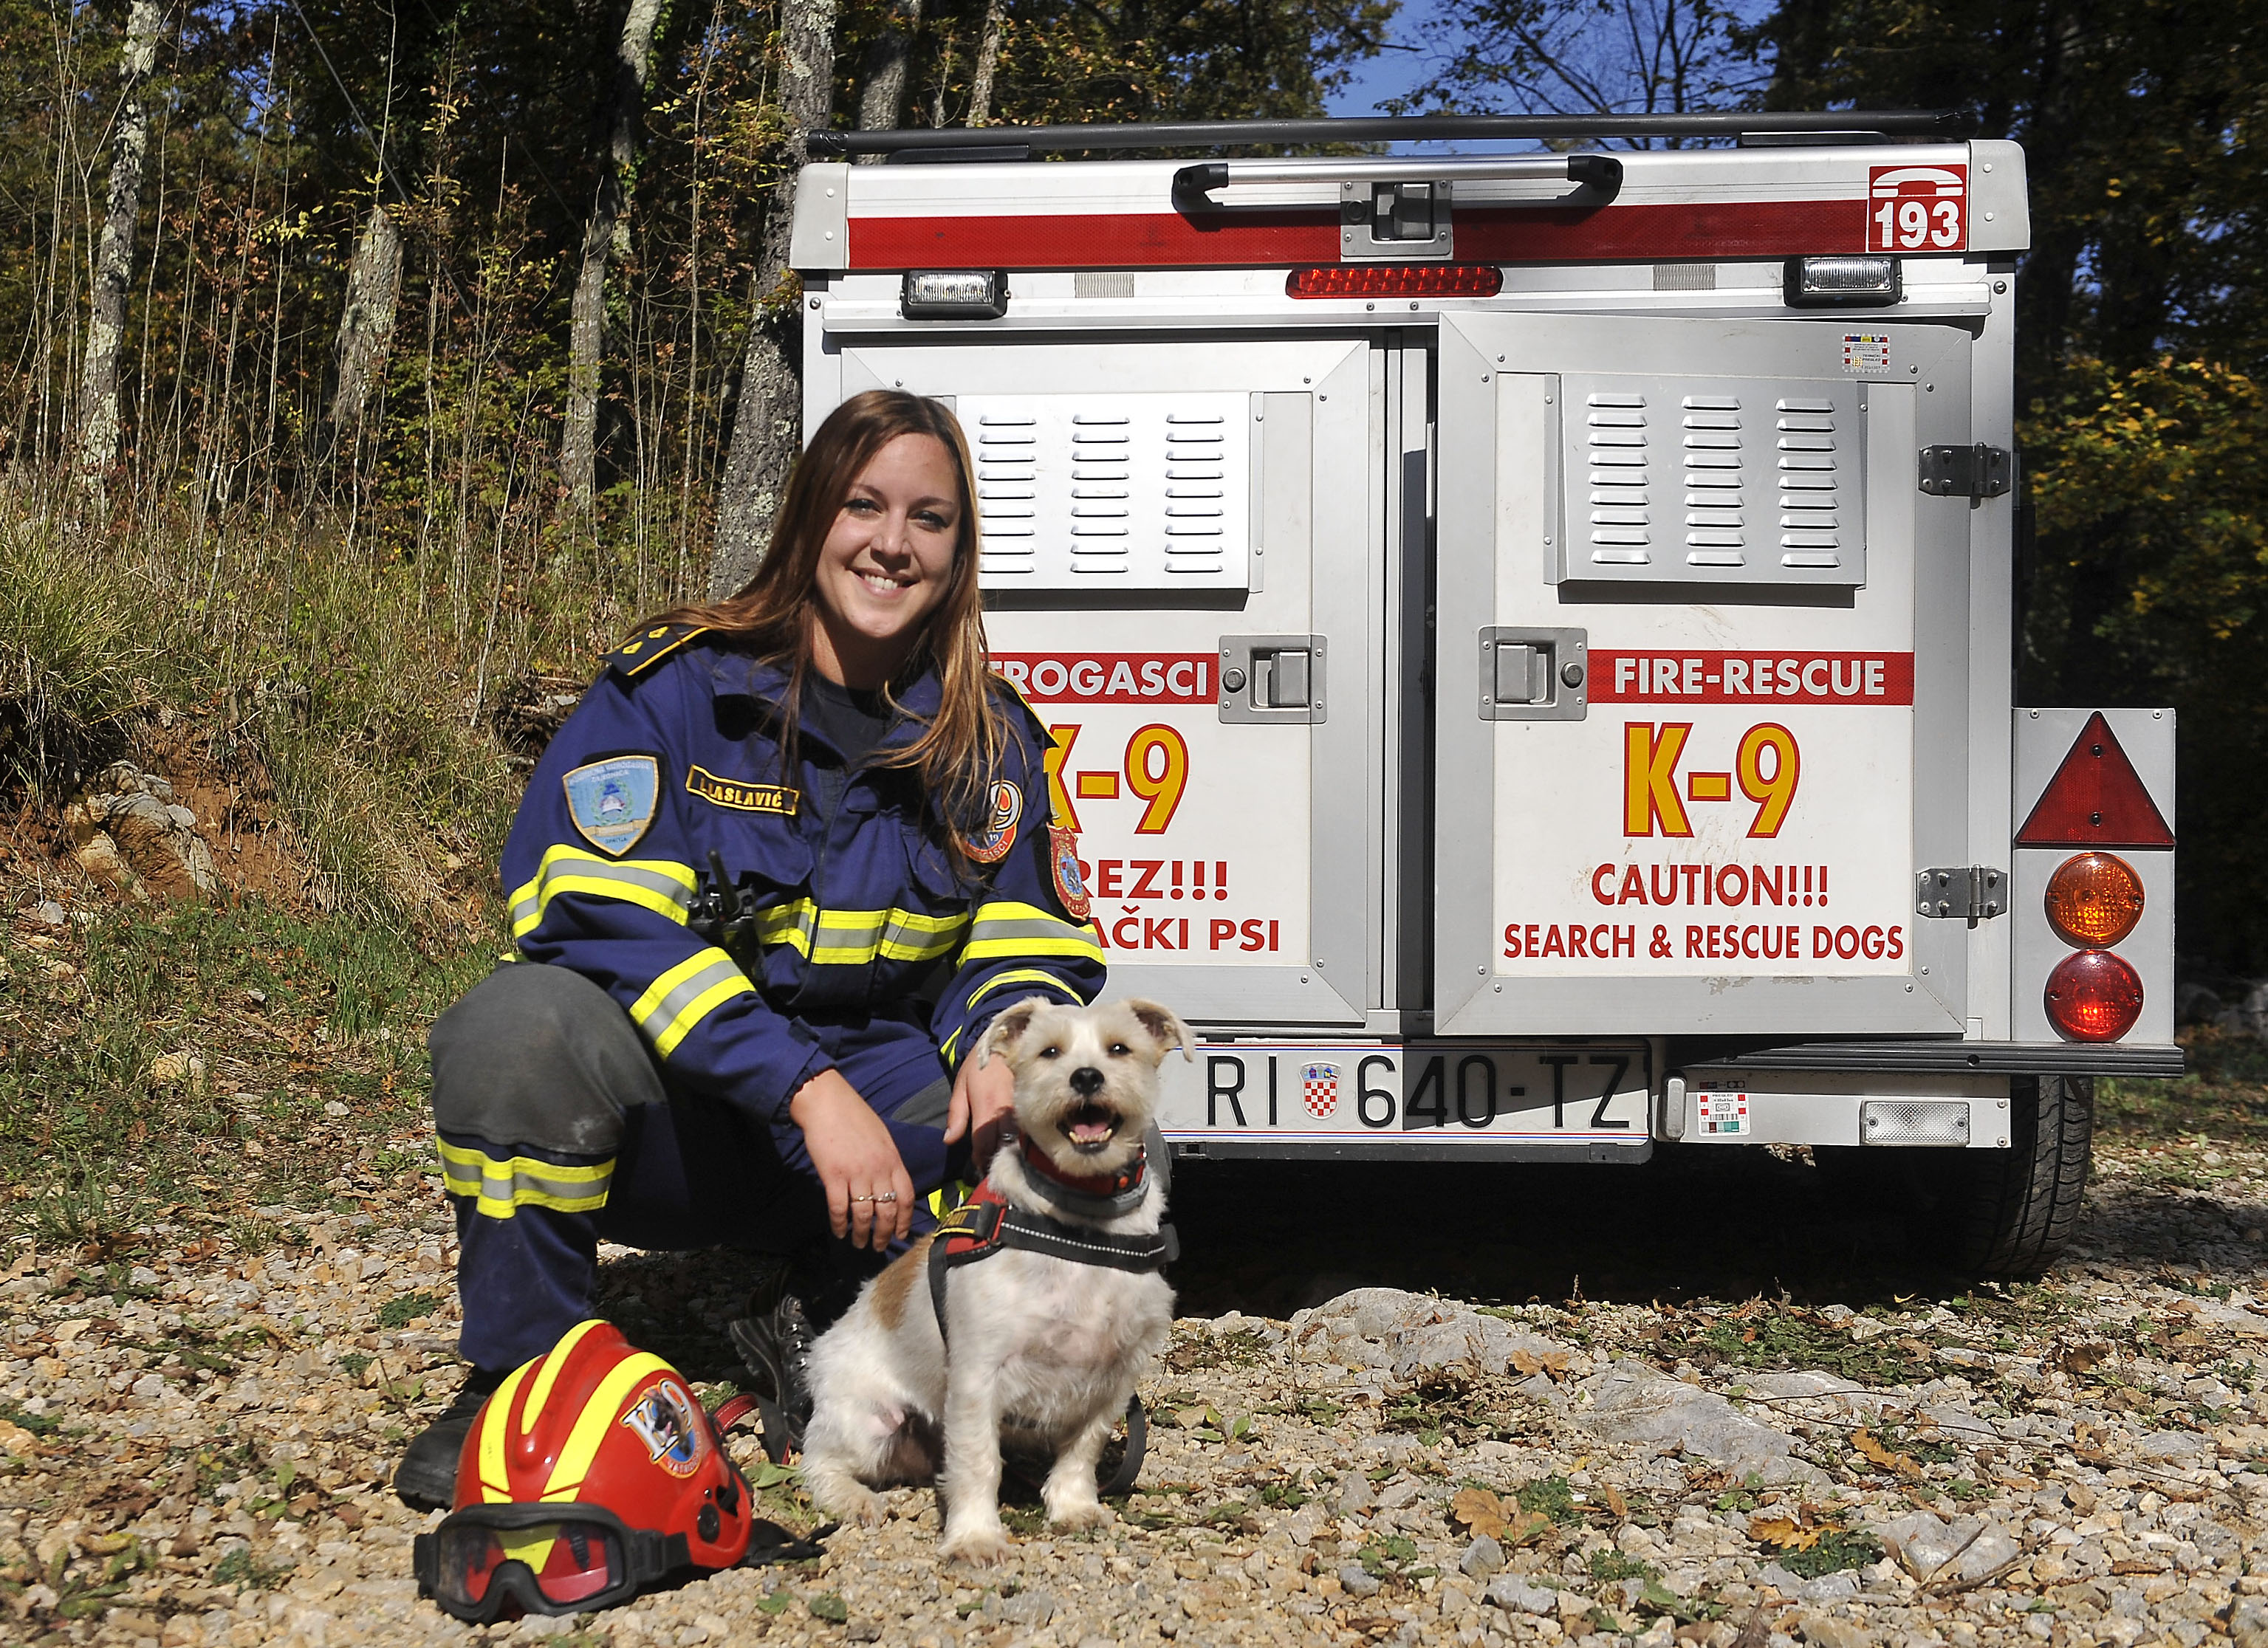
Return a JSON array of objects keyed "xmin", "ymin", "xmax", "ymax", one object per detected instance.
[{"xmin": 0, "ymin": 0, "xmax": 2268, "ymax": 977}]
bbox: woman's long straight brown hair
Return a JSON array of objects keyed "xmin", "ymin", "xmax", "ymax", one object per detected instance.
[{"xmin": 648, "ymin": 390, "xmax": 1010, "ymax": 857}]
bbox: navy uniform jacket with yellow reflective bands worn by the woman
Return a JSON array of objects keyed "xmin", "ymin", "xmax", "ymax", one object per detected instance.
[{"xmin": 504, "ymin": 628, "xmax": 1103, "ymax": 1122}]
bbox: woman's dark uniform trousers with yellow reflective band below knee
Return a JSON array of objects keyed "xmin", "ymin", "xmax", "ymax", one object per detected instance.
[{"xmin": 428, "ymin": 961, "xmax": 966, "ymax": 1371}]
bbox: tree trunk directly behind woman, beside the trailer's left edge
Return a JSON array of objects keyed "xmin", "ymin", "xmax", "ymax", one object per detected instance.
[{"xmin": 710, "ymin": 0, "xmax": 835, "ymax": 596}]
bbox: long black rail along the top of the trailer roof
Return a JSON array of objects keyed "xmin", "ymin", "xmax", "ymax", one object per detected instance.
[{"xmin": 803, "ymin": 109, "xmax": 1959, "ymax": 161}]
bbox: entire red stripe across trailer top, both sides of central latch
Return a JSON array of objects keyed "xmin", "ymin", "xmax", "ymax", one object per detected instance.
[{"xmin": 851, "ymin": 199, "xmax": 1866, "ymax": 269}]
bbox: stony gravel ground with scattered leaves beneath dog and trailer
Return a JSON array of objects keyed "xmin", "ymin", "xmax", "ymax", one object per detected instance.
[{"xmin": 0, "ymin": 1119, "xmax": 2268, "ymax": 1648}]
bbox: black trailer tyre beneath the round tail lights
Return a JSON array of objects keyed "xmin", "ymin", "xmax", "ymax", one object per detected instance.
[{"xmin": 1946, "ymin": 1077, "xmax": 2096, "ymax": 1276}]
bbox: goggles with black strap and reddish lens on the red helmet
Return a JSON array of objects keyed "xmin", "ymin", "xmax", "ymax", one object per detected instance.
[{"xmin": 413, "ymin": 1500, "xmax": 688, "ymax": 1625}]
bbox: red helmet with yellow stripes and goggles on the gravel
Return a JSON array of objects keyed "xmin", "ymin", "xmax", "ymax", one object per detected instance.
[{"xmin": 415, "ymin": 1322, "xmax": 751, "ymax": 1623}]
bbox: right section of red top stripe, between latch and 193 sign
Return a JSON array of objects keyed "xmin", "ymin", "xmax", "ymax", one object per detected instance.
[{"xmin": 1454, "ymin": 199, "xmax": 1866, "ymax": 263}]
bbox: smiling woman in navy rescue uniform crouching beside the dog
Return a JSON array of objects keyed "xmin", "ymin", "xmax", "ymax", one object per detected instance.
[{"xmin": 394, "ymin": 390, "xmax": 1103, "ymax": 1505}]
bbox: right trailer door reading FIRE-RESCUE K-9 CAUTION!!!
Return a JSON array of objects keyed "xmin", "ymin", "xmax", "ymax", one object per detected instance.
[{"xmin": 1433, "ymin": 313, "xmax": 1977, "ymax": 1038}]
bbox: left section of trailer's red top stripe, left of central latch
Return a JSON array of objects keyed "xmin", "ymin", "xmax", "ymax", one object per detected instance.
[{"xmin": 851, "ymin": 206, "xmax": 1338, "ymax": 269}]
